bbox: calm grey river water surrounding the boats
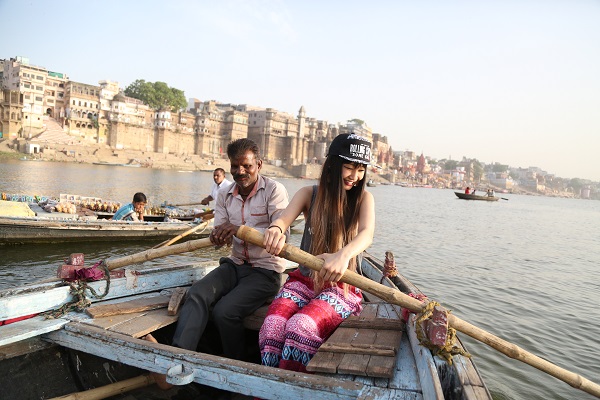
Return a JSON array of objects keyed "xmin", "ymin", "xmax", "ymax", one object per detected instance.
[{"xmin": 0, "ymin": 161, "xmax": 600, "ymax": 400}]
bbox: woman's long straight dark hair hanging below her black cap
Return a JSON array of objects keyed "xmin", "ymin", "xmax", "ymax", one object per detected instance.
[{"xmin": 310, "ymin": 155, "xmax": 367, "ymax": 291}]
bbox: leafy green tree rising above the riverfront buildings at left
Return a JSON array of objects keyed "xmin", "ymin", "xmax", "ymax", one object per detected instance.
[{"xmin": 124, "ymin": 79, "xmax": 187, "ymax": 112}]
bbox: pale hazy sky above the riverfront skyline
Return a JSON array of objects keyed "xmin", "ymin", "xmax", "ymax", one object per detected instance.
[{"xmin": 0, "ymin": 0, "xmax": 600, "ymax": 181}]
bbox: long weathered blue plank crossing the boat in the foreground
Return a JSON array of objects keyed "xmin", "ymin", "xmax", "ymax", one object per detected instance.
[{"xmin": 45, "ymin": 323, "xmax": 412, "ymax": 400}]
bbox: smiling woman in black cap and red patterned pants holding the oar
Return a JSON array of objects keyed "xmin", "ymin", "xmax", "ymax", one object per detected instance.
[{"xmin": 259, "ymin": 134, "xmax": 375, "ymax": 372}]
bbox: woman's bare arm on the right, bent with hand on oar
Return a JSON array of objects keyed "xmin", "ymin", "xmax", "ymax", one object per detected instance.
[{"xmin": 317, "ymin": 191, "xmax": 375, "ymax": 282}]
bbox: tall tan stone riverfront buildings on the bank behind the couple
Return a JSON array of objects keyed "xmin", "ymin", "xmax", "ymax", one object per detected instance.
[{"xmin": 0, "ymin": 57, "xmax": 380, "ymax": 169}]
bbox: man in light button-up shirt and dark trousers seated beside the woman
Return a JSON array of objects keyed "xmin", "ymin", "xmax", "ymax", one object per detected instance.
[{"xmin": 173, "ymin": 139, "xmax": 288, "ymax": 360}]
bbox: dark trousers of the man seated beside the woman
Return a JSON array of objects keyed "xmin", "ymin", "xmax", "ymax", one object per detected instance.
[{"xmin": 173, "ymin": 258, "xmax": 281, "ymax": 360}]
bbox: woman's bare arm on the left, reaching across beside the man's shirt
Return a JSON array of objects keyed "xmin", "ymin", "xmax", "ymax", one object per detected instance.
[{"xmin": 263, "ymin": 186, "xmax": 312, "ymax": 255}]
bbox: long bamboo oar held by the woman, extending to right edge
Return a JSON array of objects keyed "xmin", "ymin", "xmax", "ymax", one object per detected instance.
[{"xmin": 236, "ymin": 226, "xmax": 600, "ymax": 398}]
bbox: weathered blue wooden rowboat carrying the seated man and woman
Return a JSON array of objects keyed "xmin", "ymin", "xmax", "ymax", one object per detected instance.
[{"xmin": 0, "ymin": 250, "xmax": 491, "ymax": 400}]
